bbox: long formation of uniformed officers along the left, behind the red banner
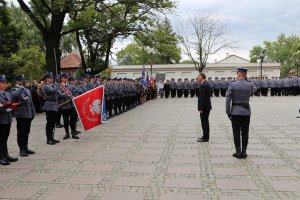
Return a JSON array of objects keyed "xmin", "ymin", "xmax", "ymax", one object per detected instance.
[{"xmin": 0, "ymin": 73, "xmax": 149, "ymax": 165}]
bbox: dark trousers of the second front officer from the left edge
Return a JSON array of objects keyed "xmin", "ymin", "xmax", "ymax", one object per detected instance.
[{"xmin": 16, "ymin": 118, "xmax": 33, "ymax": 149}]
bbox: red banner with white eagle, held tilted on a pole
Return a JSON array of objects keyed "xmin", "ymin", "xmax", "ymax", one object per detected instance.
[{"xmin": 73, "ymin": 86, "xmax": 105, "ymax": 131}]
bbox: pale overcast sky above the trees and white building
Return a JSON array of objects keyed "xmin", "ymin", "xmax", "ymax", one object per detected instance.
[{"xmin": 9, "ymin": 0, "xmax": 300, "ymax": 61}]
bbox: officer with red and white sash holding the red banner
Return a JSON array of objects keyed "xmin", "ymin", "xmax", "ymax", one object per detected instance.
[{"xmin": 58, "ymin": 73, "xmax": 79, "ymax": 140}]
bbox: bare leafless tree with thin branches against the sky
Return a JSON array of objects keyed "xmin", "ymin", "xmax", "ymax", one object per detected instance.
[{"xmin": 179, "ymin": 13, "xmax": 234, "ymax": 72}]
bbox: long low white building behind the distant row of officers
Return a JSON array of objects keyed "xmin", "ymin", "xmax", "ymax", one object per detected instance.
[{"xmin": 112, "ymin": 55, "xmax": 281, "ymax": 80}]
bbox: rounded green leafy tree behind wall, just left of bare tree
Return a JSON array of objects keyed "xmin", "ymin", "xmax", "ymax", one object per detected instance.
[{"xmin": 117, "ymin": 19, "xmax": 181, "ymax": 65}]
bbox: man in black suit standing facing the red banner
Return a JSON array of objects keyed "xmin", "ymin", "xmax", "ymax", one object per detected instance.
[{"xmin": 197, "ymin": 73, "xmax": 212, "ymax": 142}]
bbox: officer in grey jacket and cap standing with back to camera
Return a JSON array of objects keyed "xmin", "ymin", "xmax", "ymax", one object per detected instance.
[{"xmin": 226, "ymin": 68, "xmax": 256, "ymax": 159}]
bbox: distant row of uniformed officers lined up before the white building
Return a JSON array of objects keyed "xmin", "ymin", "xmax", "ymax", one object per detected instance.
[{"xmin": 157, "ymin": 77, "xmax": 300, "ymax": 98}]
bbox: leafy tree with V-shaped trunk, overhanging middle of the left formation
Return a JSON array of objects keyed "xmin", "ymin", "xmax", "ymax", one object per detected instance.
[{"xmin": 73, "ymin": 0, "xmax": 174, "ymax": 73}]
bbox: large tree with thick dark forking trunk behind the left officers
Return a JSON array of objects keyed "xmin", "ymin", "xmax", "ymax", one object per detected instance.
[{"xmin": 17, "ymin": 0, "xmax": 90, "ymax": 73}]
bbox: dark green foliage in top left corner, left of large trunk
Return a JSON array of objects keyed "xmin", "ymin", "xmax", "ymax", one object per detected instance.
[{"xmin": 0, "ymin": 0, "xmax": 20, "ymax": 58}]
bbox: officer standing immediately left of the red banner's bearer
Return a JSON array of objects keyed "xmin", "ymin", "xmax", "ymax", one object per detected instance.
[{"xmin": 43, "ymin": 72, "xmax": 59, "ymax": 145}]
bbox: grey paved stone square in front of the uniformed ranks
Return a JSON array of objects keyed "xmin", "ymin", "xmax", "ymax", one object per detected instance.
[{"xmin": 0, "ymin": 97, "xmax": 300, "ymax": 200}]
